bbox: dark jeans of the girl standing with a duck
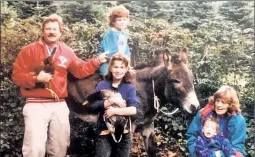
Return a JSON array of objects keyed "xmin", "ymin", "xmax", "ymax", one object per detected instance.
[{"xmin": 96, "ymin": 133, "xmax": 131, "ymax": 157}]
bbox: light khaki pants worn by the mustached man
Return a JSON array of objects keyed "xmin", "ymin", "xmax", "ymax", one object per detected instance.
[{"xmin": 22, "ymin": 101, "xmax": 70, "ymax": 157}]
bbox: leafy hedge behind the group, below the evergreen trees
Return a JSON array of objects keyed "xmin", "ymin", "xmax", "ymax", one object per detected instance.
[{"xmin": 0, "ymin": 7, "xmax": 254, "ymax": 156}]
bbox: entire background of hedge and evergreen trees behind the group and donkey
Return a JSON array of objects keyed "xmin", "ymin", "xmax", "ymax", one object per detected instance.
[{"xmin": 0, "ymin": 1, "xmax": 255, "ymax": 157}]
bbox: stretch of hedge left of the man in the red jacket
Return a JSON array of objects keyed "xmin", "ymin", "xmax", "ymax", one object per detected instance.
[{"xmin": 0, "ymin": 15, "xmax": 40, "ymax": 157}]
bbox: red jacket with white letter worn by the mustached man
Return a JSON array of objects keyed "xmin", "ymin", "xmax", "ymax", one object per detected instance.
[{"xmin": 12, "ymin": 40, "xmax": 100, "ymax": 99}]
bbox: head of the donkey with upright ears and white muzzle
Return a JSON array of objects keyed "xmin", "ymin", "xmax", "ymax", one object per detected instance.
[{"xmin": 156, "ymin": 48, "xmax": 199, "ymax": 114}]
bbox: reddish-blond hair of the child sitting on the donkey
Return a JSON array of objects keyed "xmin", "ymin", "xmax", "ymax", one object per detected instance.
[{"xmin": 109, "ymin": 6, "xmax": 129, "ymax": 27}]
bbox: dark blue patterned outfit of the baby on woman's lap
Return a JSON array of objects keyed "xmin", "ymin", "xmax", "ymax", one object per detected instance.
[{"xmin": 195, "ymin": 131, "xmax": 236, "ymax": 157}]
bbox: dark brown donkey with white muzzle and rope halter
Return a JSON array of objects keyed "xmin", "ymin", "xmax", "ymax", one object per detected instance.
[{"xmin": 67, "ymin": 48, "xmax": 199, "ymax": 157}]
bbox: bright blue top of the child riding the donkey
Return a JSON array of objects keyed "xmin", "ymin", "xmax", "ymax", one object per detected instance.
[{"xmin": 98, "ymin": 28, "xmax": 130, "ymax": 76}]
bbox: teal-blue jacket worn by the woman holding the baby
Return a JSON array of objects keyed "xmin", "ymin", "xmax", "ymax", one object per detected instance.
[{"xmin": 186, "ymin": 111, "xmax": 246, "ymax": 157}]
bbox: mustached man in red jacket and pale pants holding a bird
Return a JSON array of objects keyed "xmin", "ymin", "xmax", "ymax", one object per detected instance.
[{"xmin": 12, "ymin": 15, "xmax": 107, "ymax": 157}]
